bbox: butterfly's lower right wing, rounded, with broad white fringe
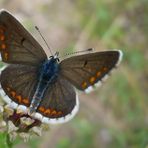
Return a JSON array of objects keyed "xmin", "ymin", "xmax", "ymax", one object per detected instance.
[{"xmin": 35, "ymin": 75, "xmax": 79, "ymax": 124}]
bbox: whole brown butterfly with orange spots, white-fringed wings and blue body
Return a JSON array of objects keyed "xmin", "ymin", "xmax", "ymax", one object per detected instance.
[{"xmin": 0, "ymin": 10, "xmax": 122, "ymax": 124}]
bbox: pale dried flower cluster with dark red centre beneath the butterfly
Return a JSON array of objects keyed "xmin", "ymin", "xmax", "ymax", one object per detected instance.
[{"xmin": 0, "ymin": 101, "xmax": 49, "ymax": 141}]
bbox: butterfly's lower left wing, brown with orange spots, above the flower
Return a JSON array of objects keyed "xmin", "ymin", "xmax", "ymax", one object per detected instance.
[{"xmin": 0, "ymin": 64, "xmax": 37, "ymax": 108}]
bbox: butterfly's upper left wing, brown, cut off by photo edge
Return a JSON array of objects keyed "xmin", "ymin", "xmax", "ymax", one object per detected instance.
[{"xmin": 0, "ymin": 10, "xmax": 47, "ymax": 65}]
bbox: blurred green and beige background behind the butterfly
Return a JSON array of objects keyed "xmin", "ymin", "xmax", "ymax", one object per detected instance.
[{"xmin": 0, "ymin": 0, "xmax": 148, "ymax": 148}]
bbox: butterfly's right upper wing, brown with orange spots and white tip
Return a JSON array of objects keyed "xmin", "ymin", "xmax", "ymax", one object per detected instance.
[{"xmin": 60, "ymin": 50, "xmax": 122, "ymax": 92}]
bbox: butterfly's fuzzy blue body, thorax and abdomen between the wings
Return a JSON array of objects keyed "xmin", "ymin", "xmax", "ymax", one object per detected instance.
[{"xmin": 30, "ymin": 57, "xmax": 59, "ymax": 113}]
